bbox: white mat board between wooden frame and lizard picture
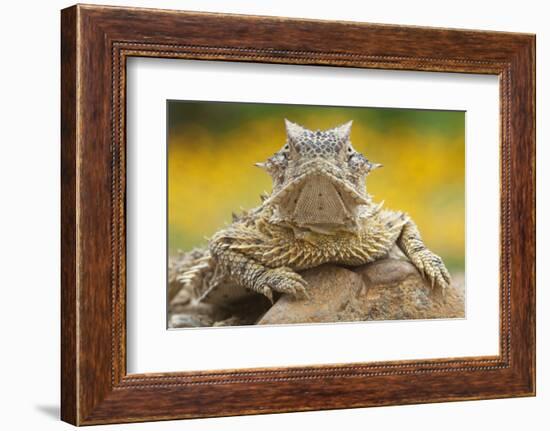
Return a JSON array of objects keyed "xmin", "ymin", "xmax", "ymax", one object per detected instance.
[{"xmin": 127, "ymin": 58, "xmax": 499, "ymax": 373}]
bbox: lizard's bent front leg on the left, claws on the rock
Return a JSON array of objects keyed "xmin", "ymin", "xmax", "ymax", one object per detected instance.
[{"xmin": 210, "ymin": 229, "xmax": 307, "ymax": 302}]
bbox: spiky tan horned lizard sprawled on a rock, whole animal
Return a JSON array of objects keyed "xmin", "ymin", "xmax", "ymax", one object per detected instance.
[{"xmin": 180, "ymin": 121, "xmax": 450, "ymax": 301}]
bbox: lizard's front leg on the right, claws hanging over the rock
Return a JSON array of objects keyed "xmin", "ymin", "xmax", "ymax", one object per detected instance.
[{"xmin": 397, "ymin": 219, "xmax": 451, "ymax": 290}]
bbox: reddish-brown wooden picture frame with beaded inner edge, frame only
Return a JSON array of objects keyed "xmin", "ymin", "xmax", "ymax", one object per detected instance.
[{"xmin": 61, "ymin": 5, "xmax": 535, "ymax": 425}]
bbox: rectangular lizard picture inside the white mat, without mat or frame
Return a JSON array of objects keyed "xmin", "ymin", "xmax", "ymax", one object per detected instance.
[{"xmin": 166, "ymin": 100, "xmax": 466, "ymax": 329}]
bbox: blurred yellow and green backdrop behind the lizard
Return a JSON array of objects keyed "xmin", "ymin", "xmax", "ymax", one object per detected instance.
[{"xmin": 168, "ymin": 101, "xmax": 465, "ymax": 271}]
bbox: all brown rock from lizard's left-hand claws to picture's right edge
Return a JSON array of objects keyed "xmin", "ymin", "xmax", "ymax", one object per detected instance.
[{"xmin": 258, "ymin": 259, "xmax": 464, "ymax": 325}]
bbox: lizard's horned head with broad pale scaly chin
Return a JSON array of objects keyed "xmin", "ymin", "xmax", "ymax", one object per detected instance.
[{"xmin": 257, "ymin": 120, "xmax": 381, "ymax": 233}]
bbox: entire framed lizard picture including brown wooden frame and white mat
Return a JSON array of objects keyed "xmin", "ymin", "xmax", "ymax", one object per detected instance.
[{"xmin": 61, "ymin": 5, "xmax": 535, "ymax": 425}]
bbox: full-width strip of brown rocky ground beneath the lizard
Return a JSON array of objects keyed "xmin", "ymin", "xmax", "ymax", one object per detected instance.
[{"xmin": 168, "ymin": 253, "xmax": 465, "ymax": 328}]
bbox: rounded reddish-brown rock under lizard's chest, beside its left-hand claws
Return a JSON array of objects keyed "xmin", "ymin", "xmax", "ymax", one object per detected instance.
[{"xmin": 258, "ymin": 265, "xmax": 365, "ymax": 325}]
